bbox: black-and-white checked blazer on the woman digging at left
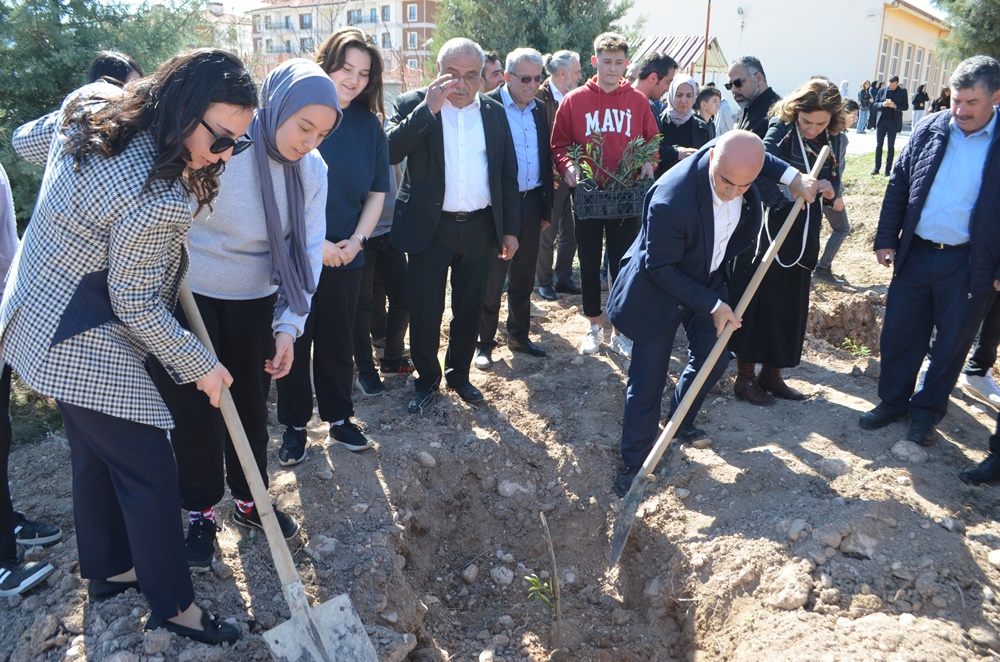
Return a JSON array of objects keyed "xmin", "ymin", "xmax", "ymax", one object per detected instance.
[{"xmin": 0, "ymin": 97, "xmax": 216, "ymax": 429}]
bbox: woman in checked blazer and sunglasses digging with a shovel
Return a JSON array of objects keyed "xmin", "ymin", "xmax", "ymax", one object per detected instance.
[{"xmin": 0, "ymin": 49, "xmax": 257, "ymax": 644}]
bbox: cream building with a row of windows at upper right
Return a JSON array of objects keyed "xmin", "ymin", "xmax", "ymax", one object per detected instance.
[{"xmin": 633, "ymin": 0, "xmax": 957, "ymax": 122}]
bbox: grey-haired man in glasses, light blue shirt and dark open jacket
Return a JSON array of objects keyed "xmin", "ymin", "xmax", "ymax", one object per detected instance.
[{"xmin": 473, "ymin": 48, "xmax": 552, "ymax": 370}]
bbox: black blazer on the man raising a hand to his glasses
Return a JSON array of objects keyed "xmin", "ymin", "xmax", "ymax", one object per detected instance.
[{"xmin": 386, "ymin": 88, "xmax": 521, "ymax": 253}]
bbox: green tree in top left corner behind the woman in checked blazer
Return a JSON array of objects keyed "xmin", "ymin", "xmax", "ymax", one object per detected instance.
[{"xmin": 0, "ymin": 0, "xmax": 211, "ymax": 226}]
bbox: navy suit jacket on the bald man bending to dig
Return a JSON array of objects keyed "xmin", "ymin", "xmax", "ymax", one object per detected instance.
[{"xmin": 607, "ymin": 141, "xmax": 768, "ymax": 343}]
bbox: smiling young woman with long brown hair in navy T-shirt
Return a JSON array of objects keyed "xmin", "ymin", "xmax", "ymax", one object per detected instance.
[{"xmin": 277, "ymin": 27, "xmax": 388, "ymax": 465}]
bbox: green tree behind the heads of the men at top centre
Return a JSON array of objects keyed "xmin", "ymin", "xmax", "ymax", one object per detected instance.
[{"xmin": 433, "ymin": 0, "xmax": 638, "ymax": 78}]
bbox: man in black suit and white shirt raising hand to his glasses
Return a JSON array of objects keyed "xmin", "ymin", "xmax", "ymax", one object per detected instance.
[{"xmin": 387, "ymin": 38, "xmax": 520, "ymax": 414}]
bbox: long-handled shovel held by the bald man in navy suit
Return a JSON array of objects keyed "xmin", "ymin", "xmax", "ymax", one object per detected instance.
[{"xmin": 608, "ymin": 147, "xmax": 830, "ymax": 570}]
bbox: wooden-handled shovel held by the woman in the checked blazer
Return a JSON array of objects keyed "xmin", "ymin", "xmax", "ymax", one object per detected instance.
[{"xmin": 180, "ymin": 281, "xmax": 378, "ymax": 662}]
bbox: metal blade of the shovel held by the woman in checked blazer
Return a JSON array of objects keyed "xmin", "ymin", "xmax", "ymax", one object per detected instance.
[{"xmin": 264, "ymin": 593, "xmax": 378, "ymax": 662}]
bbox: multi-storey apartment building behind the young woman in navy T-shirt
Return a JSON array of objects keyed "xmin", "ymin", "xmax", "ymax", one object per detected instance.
[{"xmin": 248, "ymin": 0, "xmax": 437, "ymax": 93}]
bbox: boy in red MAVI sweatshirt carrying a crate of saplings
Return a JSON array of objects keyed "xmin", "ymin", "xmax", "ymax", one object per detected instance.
[{"xmin": 552, "ymin": 32, "xmax": 659, "ymax": 357}]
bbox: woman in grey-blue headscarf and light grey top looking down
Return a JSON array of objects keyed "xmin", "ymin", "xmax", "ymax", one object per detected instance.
[{"xmin": 151, "ymin": 59, "xmax": 340, "ymax": 572}]
